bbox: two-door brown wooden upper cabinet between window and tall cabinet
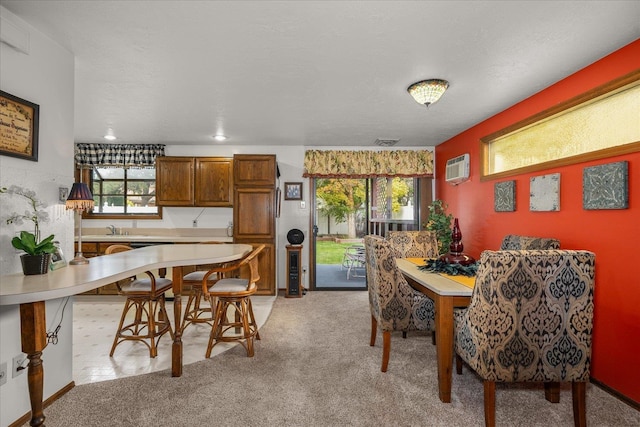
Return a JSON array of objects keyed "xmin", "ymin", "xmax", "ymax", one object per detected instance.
[{"xmin": 156, "ymin": 156, "xmax": 233, "ymax": 207}]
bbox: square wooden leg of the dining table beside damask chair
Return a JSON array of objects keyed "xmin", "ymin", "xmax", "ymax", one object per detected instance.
[{"xmin": 435, "ymin": 295, "xmax": 453, "ymax": 403}]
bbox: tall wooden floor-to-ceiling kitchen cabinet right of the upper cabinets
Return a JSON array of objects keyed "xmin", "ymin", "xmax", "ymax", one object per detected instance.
[{"xmin": 233, "ymin": 154, "xmax": 277, "ymax": 295}]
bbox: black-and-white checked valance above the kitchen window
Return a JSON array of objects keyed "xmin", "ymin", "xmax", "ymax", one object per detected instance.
[{"xmin": 75, "ymin": 143, "xmax": 164, "ymax": 168}]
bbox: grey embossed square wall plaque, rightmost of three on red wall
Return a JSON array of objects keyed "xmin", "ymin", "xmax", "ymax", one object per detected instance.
[{"xmin": 582, "ymin": 161, "xmax": 629, "ymax": 209}]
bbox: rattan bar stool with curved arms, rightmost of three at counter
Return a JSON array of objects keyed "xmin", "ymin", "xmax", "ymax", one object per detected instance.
[{"xmin": 202, "ymin": 245, "xmax": 265, "ymax": 358}]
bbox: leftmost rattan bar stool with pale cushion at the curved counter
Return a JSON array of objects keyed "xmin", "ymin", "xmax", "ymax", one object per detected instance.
[{"xmin": 105, "ymin": 245, "xmax": 173, "ymax": 357}]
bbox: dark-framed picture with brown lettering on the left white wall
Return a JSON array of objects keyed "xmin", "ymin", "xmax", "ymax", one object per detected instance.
[{"xmin": 0, "ymin": 90, "xmax": 40, "ymax": 162}]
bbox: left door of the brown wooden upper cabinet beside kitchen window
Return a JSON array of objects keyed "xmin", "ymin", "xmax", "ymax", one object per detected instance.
[{"xmin": 156, "ymin": 157, "xmax": 195, "ymax": 206}]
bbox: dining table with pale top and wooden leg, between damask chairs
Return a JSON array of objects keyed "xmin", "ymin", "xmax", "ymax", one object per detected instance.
[{"xmin": 396, "ymin": 258, "xmax": 473, "ymax": 403}]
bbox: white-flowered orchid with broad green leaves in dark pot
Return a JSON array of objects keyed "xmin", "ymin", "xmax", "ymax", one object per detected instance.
[{"xmin": 0, "ymin": 185, "xmax": 56, "ymax": 255}]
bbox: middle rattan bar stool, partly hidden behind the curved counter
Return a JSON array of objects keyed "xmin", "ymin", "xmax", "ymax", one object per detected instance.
[{"xmin": 182, "ymin": 241, "xmax": 224, "ymax": 332}]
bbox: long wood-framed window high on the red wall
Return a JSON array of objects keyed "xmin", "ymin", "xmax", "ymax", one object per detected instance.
[{"xmin": 481, "ymin": 72, "xmax": 640, "ymax": 180}]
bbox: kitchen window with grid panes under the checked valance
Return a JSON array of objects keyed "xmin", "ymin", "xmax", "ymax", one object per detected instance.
[{"xmin": 83, "ymin": 167, "xmax": 162, "ymax": 219}]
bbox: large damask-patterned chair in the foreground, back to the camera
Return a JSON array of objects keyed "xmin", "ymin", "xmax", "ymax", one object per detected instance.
[{"xmin": 454, "ymin": 250, "xmax": 595, "ymax": 426}]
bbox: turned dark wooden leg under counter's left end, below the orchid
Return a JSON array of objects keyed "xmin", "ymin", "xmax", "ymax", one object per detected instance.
[{"xmin": 20, "ymin": 301, "xmax": 47, "ymax": 426}]
